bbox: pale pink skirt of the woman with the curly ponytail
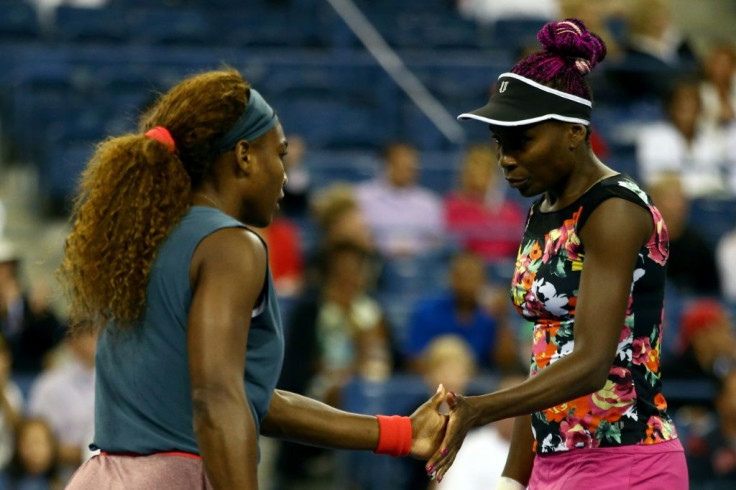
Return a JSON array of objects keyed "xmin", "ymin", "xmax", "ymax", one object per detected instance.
[{"xmin": 66, "ymin": 453, "xmax": 212, "ymax": 490}]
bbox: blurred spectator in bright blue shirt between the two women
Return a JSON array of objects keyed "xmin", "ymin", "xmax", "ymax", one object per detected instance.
[{"xmin": 404, "ymin": 252, "xmax": 516, "ymax": 372}]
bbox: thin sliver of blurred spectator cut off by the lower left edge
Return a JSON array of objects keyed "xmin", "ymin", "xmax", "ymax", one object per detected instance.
[{"xmin": 0, "ymin": 336, "xmax": 23, "ymax": 470}]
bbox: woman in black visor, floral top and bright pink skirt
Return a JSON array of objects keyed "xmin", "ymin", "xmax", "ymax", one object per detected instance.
[{"xmin": 427, "ymin": 19, "xmax": 688, "ymax": 490}]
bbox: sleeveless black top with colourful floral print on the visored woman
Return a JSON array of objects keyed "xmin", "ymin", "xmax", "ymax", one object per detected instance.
[{"xmin": 511, "ymin": 174, "xmax": 677, "ymax": 454}]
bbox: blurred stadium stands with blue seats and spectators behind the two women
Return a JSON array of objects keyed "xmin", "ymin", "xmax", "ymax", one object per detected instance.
[{"xmin": 0, "ymin": 0, "xmax": 736, "ymax": 490}]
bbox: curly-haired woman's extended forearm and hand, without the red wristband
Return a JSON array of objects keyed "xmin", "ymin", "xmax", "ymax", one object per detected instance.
[{"xmin": 261, "ymin": 388, "xmax": 447, "ymax": 459}]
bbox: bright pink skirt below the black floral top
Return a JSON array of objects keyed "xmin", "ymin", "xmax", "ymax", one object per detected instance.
[{"xmin": 529, "ymin": 439, "xmax": 689, "ymax": 490}]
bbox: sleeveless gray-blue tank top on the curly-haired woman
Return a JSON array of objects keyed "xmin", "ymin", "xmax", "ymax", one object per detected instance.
[{"xmin": 90, "ymin": 206, "xmax": 284, "ymax": 454}]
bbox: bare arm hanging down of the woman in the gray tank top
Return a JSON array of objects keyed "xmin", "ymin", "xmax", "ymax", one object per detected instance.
[{"xmin": 187, "ymin": 228, "xmax": 266, "ymax": 490}]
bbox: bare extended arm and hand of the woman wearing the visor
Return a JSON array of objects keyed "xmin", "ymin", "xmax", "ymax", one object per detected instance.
[{"xmin": 428, "ymin": 198, "xmax": 653, "ymax": 478}]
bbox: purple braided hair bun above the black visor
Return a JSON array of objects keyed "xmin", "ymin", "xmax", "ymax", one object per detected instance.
[{"xmin": 537, "ymin": 19, "xmax": 606, "ymax": 75}]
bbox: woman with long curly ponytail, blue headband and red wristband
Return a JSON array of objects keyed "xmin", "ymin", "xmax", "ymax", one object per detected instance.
[{"xmin": 60, "ymin": 70, "xmax": 445, "ymax": 490}]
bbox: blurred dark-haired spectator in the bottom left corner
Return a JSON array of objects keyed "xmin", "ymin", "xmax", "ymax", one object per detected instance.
[{"xmin": 3, "ymin": 418, "xmax": 62, "ymax": 490}]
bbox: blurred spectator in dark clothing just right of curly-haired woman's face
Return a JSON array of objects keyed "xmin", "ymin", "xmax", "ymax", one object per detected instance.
[{"xmin": 280, "ymin": 134, "xmax": 311, "ymax": 218}]
